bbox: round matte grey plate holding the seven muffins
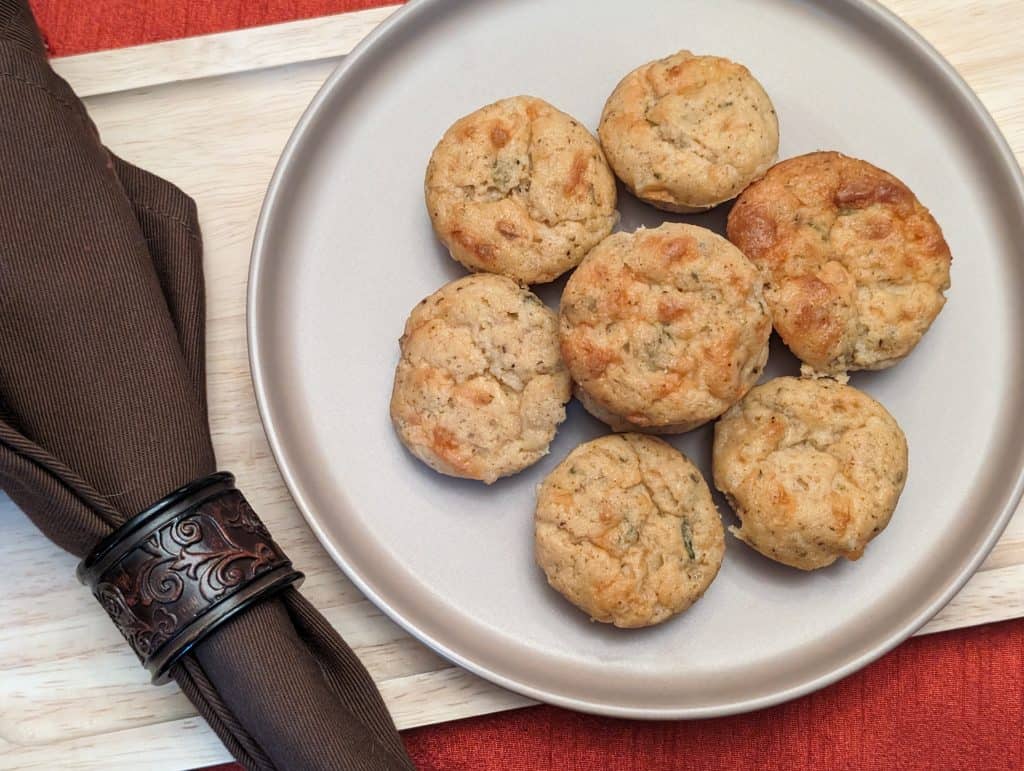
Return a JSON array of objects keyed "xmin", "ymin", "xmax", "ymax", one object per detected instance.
[{"xmin": 249, "ymin": 0, "xmax": 1024, "ymax": 718}]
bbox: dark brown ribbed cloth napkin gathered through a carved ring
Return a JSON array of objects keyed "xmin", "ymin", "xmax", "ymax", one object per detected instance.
[{"xmin": 0, "ymin": 0, "xmax": 413, "ymax": 771}]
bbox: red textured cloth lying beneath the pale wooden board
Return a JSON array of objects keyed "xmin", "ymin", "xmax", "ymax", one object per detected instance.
[{"xmin": 32, "ymin": 0, "xmax": 1024, "ymax": 771}]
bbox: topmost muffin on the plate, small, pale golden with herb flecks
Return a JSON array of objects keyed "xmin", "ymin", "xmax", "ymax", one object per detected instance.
[{"xmin": 598, "ymin": 51, "xmax": 778, "ymax": 212}]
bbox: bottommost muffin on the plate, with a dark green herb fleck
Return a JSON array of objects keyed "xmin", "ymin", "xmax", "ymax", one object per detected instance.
[{"xmin": 535, "ymin": 434, "xmax": 725, "ymax": 628}]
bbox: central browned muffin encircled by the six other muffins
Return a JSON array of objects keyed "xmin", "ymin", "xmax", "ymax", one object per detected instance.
[{"xmin": 559, "ymin": 223, "xmax": 771, "ymax": 431}]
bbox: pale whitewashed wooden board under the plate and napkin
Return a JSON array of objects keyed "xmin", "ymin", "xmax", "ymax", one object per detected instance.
[{"xmin": 0, "ymin": 0, "xmax": 1024, "ymax": 771}]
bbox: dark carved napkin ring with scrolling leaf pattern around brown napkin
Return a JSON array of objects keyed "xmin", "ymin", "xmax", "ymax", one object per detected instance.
[{"xmin": 78, "ymin": 471, "xmax": 303, "ymax": 684}]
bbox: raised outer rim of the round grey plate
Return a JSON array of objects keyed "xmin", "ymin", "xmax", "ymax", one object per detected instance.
[{"xmin": 246, "ymin": 0, "xmax": 1024, "ymax": 720}]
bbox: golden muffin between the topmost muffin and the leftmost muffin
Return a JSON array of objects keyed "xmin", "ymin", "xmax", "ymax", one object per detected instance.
[{"xmin": 425, "ymin": 96, "xmax": 617, "ymax": 284}]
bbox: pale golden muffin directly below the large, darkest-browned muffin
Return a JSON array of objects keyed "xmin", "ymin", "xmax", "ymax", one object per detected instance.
[{"xmin": 713, "ymin": 378, "xmax": 907, "ymax": 570}]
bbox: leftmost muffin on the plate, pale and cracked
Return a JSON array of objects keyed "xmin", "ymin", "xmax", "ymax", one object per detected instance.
[{"xmin": 391, "ymin": 274, "xmax": 570, "ymax": 483}]
